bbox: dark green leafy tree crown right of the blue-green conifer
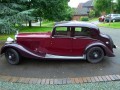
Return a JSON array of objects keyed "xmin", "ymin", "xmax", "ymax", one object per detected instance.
[{"xmin": 31, "ymin": 0, "xmax": 72, "ymax": 21}]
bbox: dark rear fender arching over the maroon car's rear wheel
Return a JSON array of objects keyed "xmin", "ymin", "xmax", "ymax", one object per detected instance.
[{"xmin": 84, "ymin": 42, "xmax": 115, "ymax": 57}]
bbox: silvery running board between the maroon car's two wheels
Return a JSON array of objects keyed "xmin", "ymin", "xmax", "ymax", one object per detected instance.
[{"xmin": 45, "ymin": 54, "xmax": 86, "ymax": 59}]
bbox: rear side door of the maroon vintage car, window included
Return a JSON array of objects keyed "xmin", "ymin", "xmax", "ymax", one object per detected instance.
[{"xmin": 72, "ymin": 27, "xmax": 93, "ymax": 56}]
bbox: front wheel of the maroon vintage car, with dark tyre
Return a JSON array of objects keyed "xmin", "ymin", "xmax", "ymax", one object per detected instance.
[{"xmin": 5, "ymin": 48, "xmax": 20, "ymax": 65}]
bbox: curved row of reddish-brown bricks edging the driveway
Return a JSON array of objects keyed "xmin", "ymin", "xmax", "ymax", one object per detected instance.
[{"xmin": 0, "ymin": 75, "xmax": 120, "ymax": 85}]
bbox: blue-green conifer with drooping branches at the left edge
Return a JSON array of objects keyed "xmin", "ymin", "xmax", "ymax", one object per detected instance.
[{"xmin": 0, "ymin": 0, "xmax": 32, "ymax": 34}]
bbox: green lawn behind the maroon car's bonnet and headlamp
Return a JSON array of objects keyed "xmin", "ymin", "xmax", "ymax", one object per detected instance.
[{"xmin": 0, "ymin": 27, "xmax": 52, "ymax": 41}]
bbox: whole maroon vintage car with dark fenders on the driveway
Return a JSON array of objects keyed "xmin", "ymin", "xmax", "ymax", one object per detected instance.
[{"xmin": 1, "ymin": 21, "xmax": 115, "ymax": 65}]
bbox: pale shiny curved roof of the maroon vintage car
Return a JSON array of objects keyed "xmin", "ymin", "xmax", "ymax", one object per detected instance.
[{"xmin": 55, "ymin": 21, "xmax": 99, "ymax": 30}]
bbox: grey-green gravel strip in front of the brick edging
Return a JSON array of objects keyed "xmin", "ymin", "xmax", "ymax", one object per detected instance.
[{"xmin": 0, "ymin": 81, "xmax": 120, "ymax": 90}]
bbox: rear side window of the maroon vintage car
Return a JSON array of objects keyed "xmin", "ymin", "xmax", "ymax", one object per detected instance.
[{"xmin": 74, "ymin": 27, "xmax": 90, "ymax": 36}]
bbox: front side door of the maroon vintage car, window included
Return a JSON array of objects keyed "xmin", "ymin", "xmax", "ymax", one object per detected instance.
[{"xmin": 48, "ymin": 27, "xmax": 72, "ymax": 56}]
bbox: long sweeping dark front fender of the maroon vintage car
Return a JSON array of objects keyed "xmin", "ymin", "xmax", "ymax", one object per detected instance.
[{"xmin": 1, "ymin": 43, "xmax": 46, "ymax": 59}]
